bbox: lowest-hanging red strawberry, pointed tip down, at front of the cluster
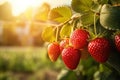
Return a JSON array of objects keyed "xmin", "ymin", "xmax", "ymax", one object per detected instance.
[{"xmin": 62, "ymin": 47, "xmax": 81, "ymax": 70}]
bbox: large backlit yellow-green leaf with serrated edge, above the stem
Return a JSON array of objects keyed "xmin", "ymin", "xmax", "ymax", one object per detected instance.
[{"xmin": 48, "ymin": 6, "xmax": 72, "ymax": 23}]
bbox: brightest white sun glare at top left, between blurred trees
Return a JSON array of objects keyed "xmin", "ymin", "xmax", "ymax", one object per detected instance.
[{"xmin": 8, "ymin": 0, "xmax": 44, "ymax": 16}]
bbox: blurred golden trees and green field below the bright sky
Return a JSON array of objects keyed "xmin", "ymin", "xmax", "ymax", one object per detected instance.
[{"xmin": 0, "ymin": 0, "xmax": 63, "ymax": 80}]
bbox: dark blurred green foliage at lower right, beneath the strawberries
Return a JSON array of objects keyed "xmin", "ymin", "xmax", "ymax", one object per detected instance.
[{"xmin": 58, "ymin": 58, "xmax": 120, "ymax": 80}]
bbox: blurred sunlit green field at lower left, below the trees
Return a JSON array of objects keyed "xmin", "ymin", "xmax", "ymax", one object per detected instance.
[{"xmin": 0, "ymin": 47, "xmax": 62, "ymax": 80}]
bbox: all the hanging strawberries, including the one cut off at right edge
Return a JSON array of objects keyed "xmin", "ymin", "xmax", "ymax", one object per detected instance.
[{"xmin": 48, "ymin": 29, "xmax": 120, "ymax": 70}]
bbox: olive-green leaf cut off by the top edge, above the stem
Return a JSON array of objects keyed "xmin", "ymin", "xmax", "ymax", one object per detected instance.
[{"xmin": 71, "ymin": 0, "xmax": 93, "ymax": 13}]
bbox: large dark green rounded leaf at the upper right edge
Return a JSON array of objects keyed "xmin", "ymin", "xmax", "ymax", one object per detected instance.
[{"xmin": 100, "ymin": 4, "xmax": 120, "ymax": 30}]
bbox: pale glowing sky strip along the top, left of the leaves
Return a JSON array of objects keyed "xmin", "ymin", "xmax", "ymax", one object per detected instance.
[{"xmin": 6, "ymin": 0, "xmax": 71, "ymax": 16}]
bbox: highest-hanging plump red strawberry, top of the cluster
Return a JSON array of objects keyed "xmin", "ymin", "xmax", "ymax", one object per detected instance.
[{"xmin": 70, "ymin": 29, "xmax": 89, "ymax": 49}]
